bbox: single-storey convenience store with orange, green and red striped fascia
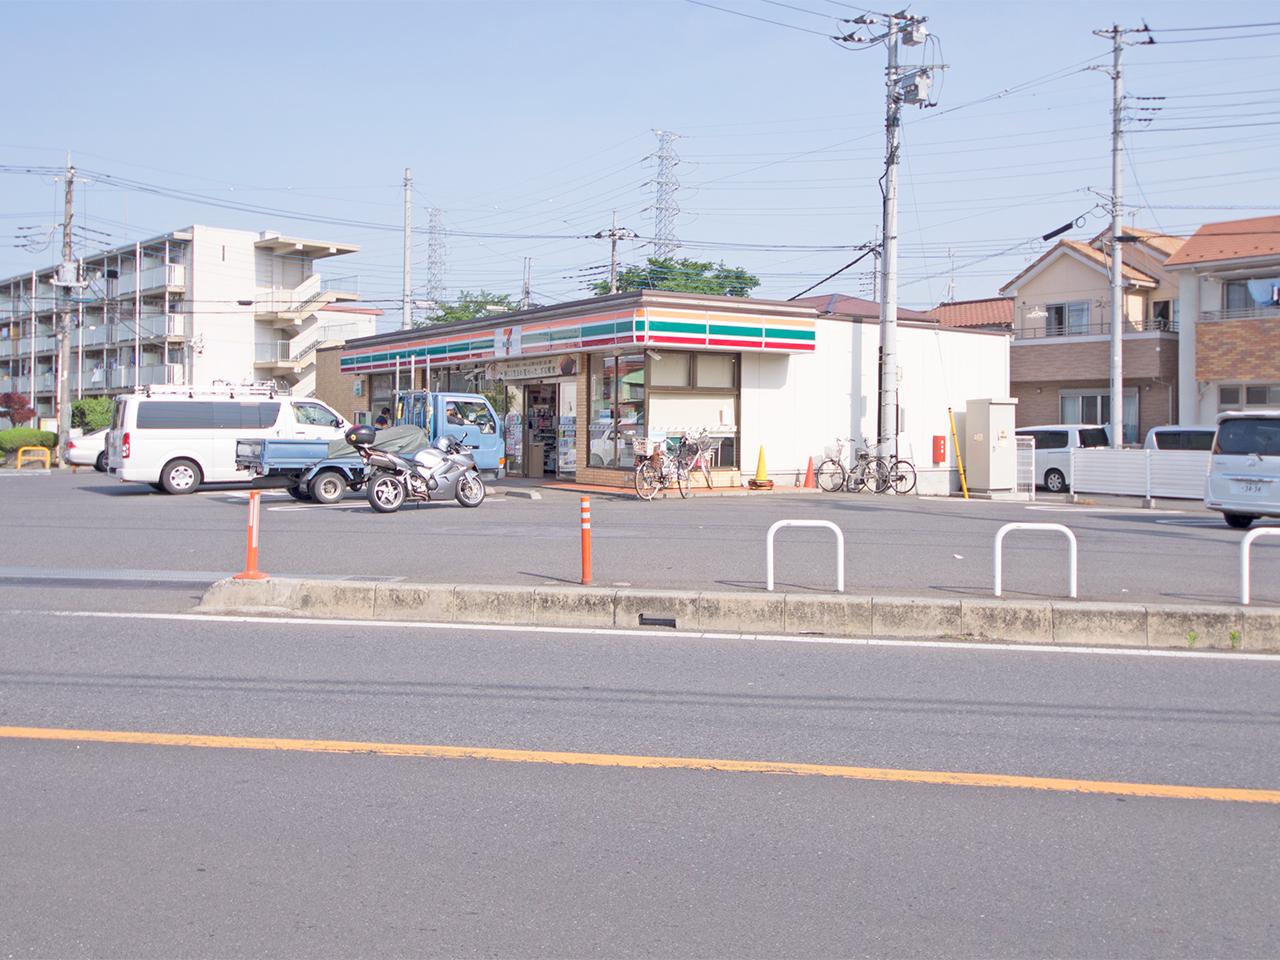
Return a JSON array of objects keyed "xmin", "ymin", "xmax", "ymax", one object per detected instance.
[{"xmin": 335, "ymin": 291, "xmax": 1009, "ymax": 486}]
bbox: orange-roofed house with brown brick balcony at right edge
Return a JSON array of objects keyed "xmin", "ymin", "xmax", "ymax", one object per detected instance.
[{"xmin": 1166, "ymin": 216, "xmax": 1280, "ymax": 424}]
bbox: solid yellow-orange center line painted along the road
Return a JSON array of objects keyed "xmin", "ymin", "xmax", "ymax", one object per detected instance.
[{"xmin": 0, "ymin": 727, "xmax": 1280, "ymax": 804}]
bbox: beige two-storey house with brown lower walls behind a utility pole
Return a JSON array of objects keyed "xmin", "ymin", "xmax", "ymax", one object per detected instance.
[{"xmin": 1000, "ymin": 227, "xmax": 1185, "ymax": 443}]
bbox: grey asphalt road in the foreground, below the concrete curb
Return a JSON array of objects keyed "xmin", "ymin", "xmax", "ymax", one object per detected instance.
[{"xmin": 0, "ymin": 611, "xmax": 1280, "ymax": 957}]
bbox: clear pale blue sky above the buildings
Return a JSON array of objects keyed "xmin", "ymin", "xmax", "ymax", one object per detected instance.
[{"xmin": 0, "ymin": 0, "xmax": 1280, "ymax": 327}]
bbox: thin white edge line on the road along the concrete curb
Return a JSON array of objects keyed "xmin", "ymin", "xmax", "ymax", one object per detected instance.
[{"xmin": 6, "ymin": 609, "xmax": 1280, "ymax": 664}]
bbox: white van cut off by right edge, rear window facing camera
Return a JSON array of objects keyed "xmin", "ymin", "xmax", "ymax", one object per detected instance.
[{"xmin": 1204, "ymin": 411, "xmax": 1280, "ymax": 530}]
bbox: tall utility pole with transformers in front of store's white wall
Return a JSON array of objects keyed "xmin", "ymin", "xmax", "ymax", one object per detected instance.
[{"xmin": 840, "ymin": 10, "xmax": 942, "ymax": 457}]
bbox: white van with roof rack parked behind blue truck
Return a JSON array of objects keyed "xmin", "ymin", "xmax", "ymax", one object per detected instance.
[{"xmin": 106, "ymin": 387, "xmax": 347, "ymax": 493}]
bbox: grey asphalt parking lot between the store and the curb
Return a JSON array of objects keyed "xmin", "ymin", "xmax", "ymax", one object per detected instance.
[{"xmin": 0, "ymin": 471, "xmax": 1280, "ymax": 604}]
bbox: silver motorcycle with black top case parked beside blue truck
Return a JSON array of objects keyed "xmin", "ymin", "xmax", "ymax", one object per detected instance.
[{"xmin": 344, "ymin": 426, "xmax": 485, "ymax": 513}]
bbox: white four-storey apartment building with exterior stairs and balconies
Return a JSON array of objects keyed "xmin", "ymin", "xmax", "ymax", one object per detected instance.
[{"xmin": 0, "ymin": 225, "xmax": 371, "ymax": 416}]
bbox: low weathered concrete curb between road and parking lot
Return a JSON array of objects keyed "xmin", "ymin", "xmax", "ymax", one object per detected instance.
[{"xmin": 196, "ymin": 577, "xmax": 1280, "ymax": 653}]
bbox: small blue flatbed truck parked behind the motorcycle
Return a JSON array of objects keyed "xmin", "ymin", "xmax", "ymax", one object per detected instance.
[{"xmin": 236, "ymin": 392, "xmax": 507, "ymax": 503}]
